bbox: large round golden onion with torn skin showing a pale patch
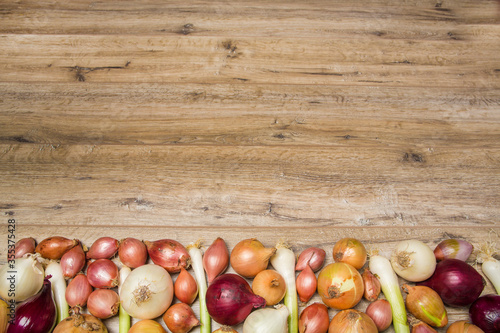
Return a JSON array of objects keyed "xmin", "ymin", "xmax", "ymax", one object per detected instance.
[{"xmin": 318, "ymin": 262, "xmax": 364, "ymax": 310}]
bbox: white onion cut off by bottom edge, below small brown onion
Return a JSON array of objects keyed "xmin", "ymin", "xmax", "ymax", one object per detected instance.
[{"xmin": 243, "ymin": 304, "xmax": 288, "ymax": 333}]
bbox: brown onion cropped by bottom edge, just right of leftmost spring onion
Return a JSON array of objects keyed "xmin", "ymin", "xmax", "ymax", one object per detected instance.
[{"xmin": 52, "ymin": 307, "xmax": 108, "ymax": 333}]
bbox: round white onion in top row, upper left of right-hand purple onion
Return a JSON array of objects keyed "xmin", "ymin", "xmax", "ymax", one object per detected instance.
[{"xmin": 391, "ymin": 239, "xmax": 436, "ymax": 282}]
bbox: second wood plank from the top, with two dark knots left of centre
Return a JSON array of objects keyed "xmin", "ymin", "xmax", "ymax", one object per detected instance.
[{"xmin": 0, "ymin": 35, "xmax": 500, "ymax": 88}]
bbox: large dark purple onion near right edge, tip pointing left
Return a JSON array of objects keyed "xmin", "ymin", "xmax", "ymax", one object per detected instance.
[{"xmin": 419, "ymin": 259, "xmax": 485, "ymax": 307}]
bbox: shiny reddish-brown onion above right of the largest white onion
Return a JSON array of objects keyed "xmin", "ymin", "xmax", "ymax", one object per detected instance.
[{"xmin": 144, "ymin": 239, "xmax": 191, "ymax": 273}]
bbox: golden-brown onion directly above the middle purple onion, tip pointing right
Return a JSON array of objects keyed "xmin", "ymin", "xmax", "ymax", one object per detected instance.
[{"xmin": 230, "ymin": 238, "xmax": 276, "ymax": 278}]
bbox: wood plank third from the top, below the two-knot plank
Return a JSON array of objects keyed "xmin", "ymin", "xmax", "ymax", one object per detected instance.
[{"xmin": 0, "ymin": 82, "xmax": 500, "ymax": 145}]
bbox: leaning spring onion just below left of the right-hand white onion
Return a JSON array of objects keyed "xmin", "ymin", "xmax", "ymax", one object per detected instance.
[{"xmin": 369, "ymin": 253, "xmax": 410, "ymax": 333}]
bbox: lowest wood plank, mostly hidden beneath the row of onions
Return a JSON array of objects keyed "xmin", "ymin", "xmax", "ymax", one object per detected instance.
[{"xmin": 0, "ymin": 223, "xmax": 500, "ymax": 333}]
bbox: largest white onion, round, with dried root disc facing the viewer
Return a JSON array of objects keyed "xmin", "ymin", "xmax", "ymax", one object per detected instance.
[{"xmin": 120, "ymin": 264, "xmax": 174, "ymax": 319}]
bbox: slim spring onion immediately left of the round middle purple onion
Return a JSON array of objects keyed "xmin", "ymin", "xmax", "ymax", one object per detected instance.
[{"xmin": 187, "ymin": 241, "xmax": 212, "ymax": 333}]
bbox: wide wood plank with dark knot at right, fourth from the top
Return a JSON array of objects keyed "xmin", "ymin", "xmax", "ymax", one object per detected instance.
[{"xmin": 0, "ymin": 144, "xmax": 500, "ymax": 226}]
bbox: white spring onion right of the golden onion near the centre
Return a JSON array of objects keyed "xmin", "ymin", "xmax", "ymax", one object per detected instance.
[{"xmin": 271, "ymin": 243, "xmax": 299, "ymax": 333}]
